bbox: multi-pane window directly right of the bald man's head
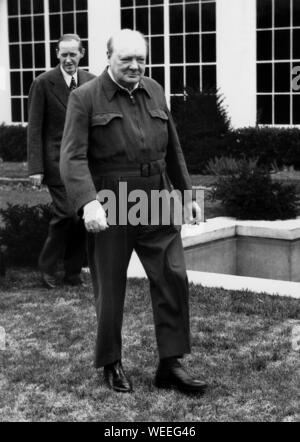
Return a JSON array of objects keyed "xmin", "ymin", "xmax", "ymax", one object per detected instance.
[{"xmin": 121, "ymin": 0, "xmax": 216, "ymax": 107}]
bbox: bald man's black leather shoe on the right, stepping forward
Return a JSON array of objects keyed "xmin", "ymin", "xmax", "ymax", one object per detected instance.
[{"xmin": 154, "ymin": 359, "xmax": 207, "ymax": 395}]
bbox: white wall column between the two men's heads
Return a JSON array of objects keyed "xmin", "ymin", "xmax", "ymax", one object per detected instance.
[{"xmin": 88, "ymin": 0, "xmax": 121, "ymax": 75}]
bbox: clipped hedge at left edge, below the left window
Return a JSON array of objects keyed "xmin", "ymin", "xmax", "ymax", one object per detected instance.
[{"xmin": 0, "ymin": 123, "xmax": 27, "ymax": 162}]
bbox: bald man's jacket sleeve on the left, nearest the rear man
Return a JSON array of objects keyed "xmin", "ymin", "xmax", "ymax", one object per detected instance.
[{"xmin": 60, "ymin": 88, "xmax": 97, "ymax": 212}]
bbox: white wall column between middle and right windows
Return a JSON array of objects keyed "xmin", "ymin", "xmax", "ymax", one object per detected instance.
[{"xmin": 216, "ymin": 0, "xmax": 256, "ymax": 128}]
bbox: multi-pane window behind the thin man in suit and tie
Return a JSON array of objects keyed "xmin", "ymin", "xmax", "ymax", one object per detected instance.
[{"xmin": 7, "ymin": 0, "xmax": 88, "ymax": 123}]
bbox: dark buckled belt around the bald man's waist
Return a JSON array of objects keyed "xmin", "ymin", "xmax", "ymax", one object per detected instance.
[{"xmin": 95, "ymin": 160, "xmax": 166, "ymax": 177}]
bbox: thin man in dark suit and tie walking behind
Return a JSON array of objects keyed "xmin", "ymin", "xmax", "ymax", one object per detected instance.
[{"xmin": 28, "ymin": 34, "xmax": 95, "ymax": 288}]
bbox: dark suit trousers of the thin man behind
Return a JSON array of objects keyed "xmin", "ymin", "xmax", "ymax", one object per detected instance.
[{"xmin": 39, "ymin": 186, "xmax": 86, "ymax": 276}]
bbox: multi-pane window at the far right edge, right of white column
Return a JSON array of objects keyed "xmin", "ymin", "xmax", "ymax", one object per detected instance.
[{"xmin": 257, "ymin": 0, "xmax": 300, "ymax": 125}]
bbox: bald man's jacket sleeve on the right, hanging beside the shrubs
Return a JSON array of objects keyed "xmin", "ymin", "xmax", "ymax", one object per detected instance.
[{"xmin": 166, "ymin": 110, "xmax": 192, "ymax": 196}]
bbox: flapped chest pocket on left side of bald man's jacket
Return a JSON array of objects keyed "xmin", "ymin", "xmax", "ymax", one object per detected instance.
[{"xmin": 90, "ymin": 112, "xmax": 125, "ymax": 158}]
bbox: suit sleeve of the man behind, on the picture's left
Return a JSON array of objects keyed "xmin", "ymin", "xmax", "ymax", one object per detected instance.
[{"xmin": 27, "ymin": 81, "xmax": 46, "ymax": 175}]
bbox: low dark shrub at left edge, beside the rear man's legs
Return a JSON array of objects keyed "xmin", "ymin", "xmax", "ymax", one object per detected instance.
[{"xmin": 0, "ymin": 204, "xmax": 52, "ymax": 266}]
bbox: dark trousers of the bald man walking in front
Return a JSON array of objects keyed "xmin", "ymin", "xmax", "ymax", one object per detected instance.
[{"xmin": 88, "ymin": 177, "xmax": 190, "ymax": 368}]
